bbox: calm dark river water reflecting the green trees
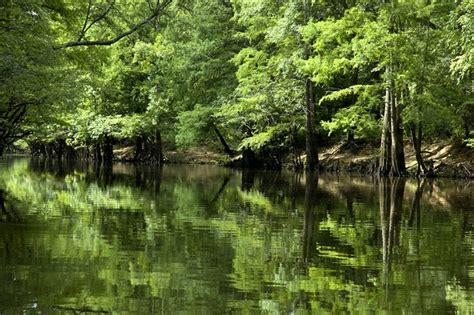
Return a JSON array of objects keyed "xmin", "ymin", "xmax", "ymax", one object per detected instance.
[{"xmin": 0, "ymin": 159, "xmax": 474, "ymax": 314}]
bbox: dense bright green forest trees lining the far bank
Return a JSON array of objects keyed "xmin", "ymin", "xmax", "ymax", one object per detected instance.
[{"xmin": 0, "ymin": 0, "xmax": 474, "ymax": 176}]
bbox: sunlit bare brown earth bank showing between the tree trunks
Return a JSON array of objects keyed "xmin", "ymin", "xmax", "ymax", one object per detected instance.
[{"xmin": 114, "ymin": 141, "xmax": 474, "ymax": 179}]
